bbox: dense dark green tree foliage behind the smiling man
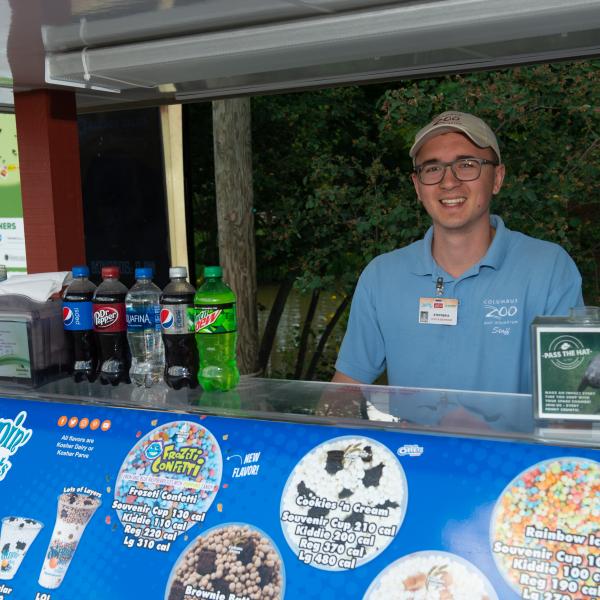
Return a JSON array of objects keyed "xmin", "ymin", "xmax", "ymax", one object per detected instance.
[{"xmin": 195, "ymin": 61, "xmax": 600, "ymax": 378}]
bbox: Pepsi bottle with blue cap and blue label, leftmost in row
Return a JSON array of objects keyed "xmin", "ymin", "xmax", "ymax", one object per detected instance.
[{"xmin": 63, "ymin": 265, "xmax": 98, "ymax": 382}]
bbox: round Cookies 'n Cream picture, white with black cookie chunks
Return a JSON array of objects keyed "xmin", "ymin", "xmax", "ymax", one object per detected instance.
[{"xmin": 280, "ymin": 436, "xmax": 408, "ymax": 571}]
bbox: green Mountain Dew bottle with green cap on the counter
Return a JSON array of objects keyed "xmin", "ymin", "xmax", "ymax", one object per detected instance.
[{"xmin": 194, "ymin": 267, "xmax": 240, "ymax": 392}]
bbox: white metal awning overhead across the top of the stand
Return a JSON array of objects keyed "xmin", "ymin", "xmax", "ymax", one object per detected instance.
[{"xmin": 0, "ymin": 0, "xmax": 600, "ymax": 109}]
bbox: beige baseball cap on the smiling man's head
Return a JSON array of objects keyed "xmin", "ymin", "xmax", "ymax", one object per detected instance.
[{"xmin": 409, "ymin": 110, "xmax": 502, "ymax": 164}]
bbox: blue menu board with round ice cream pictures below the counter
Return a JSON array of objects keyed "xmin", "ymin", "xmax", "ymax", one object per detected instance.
[{"xmin": 0, "ymin": 399, "xmax": 600, "ymax": 600}]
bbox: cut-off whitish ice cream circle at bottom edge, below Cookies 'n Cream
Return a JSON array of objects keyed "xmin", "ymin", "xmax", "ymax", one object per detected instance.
[{"xmin": 363, "ymin": 550, "xmax": 498, "ymax": 600}]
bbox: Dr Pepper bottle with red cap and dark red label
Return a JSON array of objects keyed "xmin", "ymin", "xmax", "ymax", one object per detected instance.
[{"xmin": 92, "ymin": 267, "xmax": 131, "ymax": 385}]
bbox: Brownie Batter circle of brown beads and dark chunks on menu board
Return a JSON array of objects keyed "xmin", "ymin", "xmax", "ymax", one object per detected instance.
[{"xmin": 165, "ymin": 523, "xmax": 285, "ymax": 600}]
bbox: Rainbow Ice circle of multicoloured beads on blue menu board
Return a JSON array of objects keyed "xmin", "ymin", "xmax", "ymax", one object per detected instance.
[{"xmin": 490, "ymin": 457, "xmax": 600, "ymax": 600}]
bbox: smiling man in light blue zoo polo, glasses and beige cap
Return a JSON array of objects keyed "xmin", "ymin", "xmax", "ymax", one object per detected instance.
[{"xmin": 333, "ymin": 111, "xmax": 583, "ymax": 393}]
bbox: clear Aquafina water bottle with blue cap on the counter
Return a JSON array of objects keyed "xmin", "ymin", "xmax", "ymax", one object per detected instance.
[{"xmin": 125, "ymin": 268, "xmax": 165, "ymax": 387}]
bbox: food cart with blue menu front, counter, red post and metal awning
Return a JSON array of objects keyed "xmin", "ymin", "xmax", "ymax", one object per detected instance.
[{"xmin": 0, "ymin": 0, "xmax": 600, "ymax": 600}]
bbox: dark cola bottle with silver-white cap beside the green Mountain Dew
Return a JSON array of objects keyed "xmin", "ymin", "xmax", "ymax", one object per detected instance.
[{"xmin": 160, "ymin": 267, "xmax": 198, "ymax": 390}]
